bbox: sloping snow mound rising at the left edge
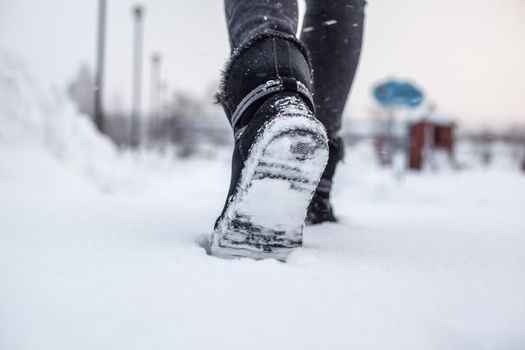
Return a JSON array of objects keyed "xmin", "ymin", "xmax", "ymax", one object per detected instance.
[{"xmin": 0, "ymin": 48, "xmax": 147, "ymax": 191}]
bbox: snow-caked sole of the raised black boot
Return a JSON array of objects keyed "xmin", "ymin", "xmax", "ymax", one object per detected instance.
[{"xmin": 210, "ymin": 109, "xmax": 328, "ymax": 261}]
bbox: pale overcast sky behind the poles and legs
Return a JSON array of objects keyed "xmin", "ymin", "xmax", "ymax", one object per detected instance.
[{"xmin": 0, "ymin": 0, "xmax": 525, "ymax": 126}]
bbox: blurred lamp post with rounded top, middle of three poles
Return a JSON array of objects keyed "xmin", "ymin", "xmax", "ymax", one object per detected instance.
[{"xmin": 131, "ymin": 5, "xmax": 144, "ymax": 147}]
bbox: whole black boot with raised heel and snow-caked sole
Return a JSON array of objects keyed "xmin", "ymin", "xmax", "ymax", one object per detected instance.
[{"xmin": 210, "ymin": 37, "xmax": 328, "ymax": 260}]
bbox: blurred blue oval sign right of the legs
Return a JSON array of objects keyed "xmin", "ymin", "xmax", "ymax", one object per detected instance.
[{"xmin": 373, "ymin": 80, "xmax": 423, "ymax": 108}]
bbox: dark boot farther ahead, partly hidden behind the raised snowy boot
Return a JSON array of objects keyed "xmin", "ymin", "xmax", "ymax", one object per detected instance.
[{"xmin": 306, "ymin": 137, "xmax": 344, "ymax": 225}]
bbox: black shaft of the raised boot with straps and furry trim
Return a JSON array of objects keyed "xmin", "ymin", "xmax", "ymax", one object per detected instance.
[{"xmin": 218, "ymin": 36, "xmax": 314, "ymax": 132}]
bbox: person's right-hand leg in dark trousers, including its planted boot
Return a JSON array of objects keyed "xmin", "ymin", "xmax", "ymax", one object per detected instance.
[{"xmin": 301, "ymin": 0, "xmax": 365, "ymax": 223}]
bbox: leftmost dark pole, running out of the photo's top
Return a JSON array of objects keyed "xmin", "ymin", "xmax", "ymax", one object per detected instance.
[{"xmin": 94, "ymin": 0, "xmax": 106, "ymax": 133}]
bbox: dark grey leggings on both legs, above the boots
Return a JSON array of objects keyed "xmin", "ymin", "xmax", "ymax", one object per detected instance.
[{"xmin": 225, "ymin": 0, "xmax": 365, "ymax": 137}]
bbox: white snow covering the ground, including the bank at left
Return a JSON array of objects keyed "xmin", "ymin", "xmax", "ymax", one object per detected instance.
[{"xmin": 0, "ymin": 52, "xmax": 525, "ymax": 350}]
